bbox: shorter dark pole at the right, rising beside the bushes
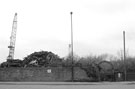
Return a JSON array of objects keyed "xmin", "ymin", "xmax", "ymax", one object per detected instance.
[{"xmin": 123, "ymin": 31, "xmax": 127, "ymax": 81}]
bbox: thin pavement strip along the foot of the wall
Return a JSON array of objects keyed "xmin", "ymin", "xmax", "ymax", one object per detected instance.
[{"xmin": 0, "ymin": 81, "xmax": 135, "ymax": 85}]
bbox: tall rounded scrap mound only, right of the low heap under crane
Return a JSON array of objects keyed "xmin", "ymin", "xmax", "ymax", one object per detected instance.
[{"xmin": 23, "ymin": 51, "xmax": 62, "ymax": 67}]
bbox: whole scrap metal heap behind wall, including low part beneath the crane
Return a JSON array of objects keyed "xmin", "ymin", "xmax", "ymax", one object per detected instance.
[{"xmin": 1, "ymin": 51, "xmax": 62, "ymax": 68}]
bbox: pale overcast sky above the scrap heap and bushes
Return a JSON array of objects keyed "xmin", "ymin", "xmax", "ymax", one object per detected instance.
[{"xmin": 0, "ymin": 0, "xmax": 135, "ymax": 62}]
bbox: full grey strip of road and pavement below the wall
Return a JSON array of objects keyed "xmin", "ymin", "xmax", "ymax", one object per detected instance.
[{"xmin": 0, "ymin": 82, "xmax": 135, "ymax": 89}]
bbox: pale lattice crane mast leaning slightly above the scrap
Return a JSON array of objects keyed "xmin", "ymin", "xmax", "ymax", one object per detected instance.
[{"xmin": 7, "ymin": 13, "xmax": 17, "ymax": 60}]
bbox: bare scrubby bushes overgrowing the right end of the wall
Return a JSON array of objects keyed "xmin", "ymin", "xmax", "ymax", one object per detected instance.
[{"xmin": 65, "ymin": 54, "xmax": 135, "ymax": 81}]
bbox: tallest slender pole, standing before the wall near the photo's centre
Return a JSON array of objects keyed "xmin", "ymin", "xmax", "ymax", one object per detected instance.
[{"xmin": 70, "ymin": 12, "xmax": 74, "ymax": 82}]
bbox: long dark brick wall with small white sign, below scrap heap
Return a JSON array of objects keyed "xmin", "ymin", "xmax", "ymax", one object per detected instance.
[{"xmin": 0, "ymin": 67, "xmax": 88, "ymax": 81}]
